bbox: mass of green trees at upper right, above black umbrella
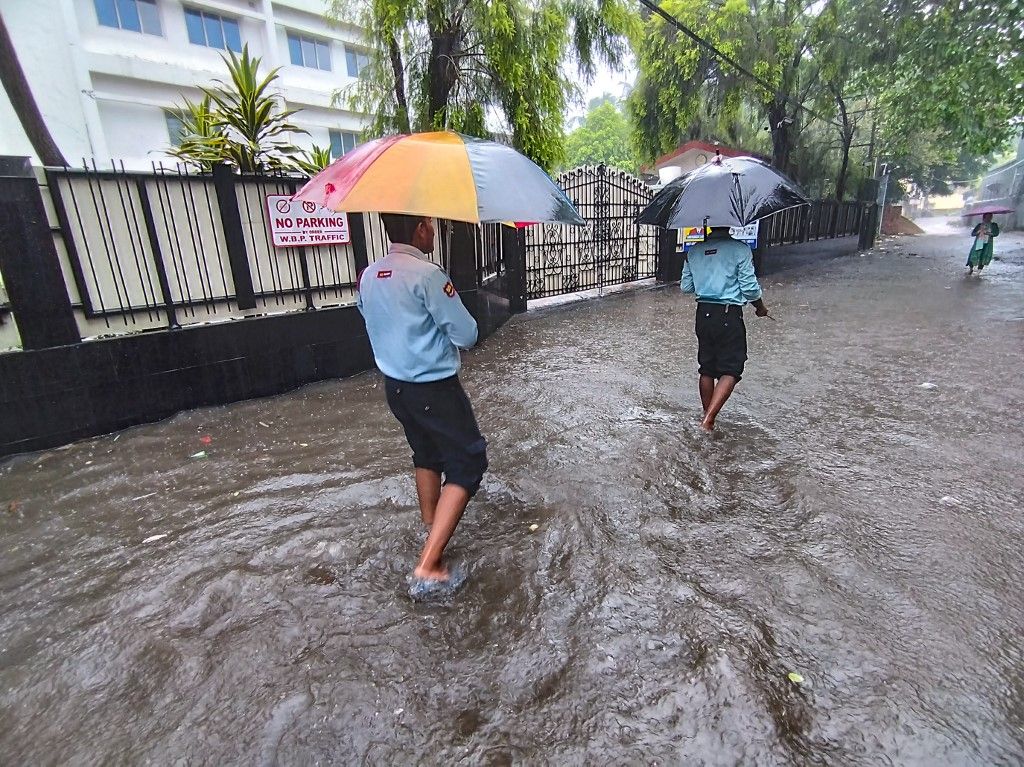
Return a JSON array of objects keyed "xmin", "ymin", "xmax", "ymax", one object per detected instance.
[{"xmin": 629, "ymin": 0, "xmax": 1024, "ymax": 197}]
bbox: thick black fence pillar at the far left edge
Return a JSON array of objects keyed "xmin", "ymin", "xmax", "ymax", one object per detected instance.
[{"xmin": 0, "ymin": 158, "xmax": 82, "ymax": 349}]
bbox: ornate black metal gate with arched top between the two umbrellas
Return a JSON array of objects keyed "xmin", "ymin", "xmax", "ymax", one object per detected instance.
[{"xmin": 526, "ymin": 165, "xmax": 658, "ymax": 299}]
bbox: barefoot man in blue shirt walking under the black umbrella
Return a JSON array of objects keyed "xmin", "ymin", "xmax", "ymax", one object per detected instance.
[{"xmin": 681, "ymin": 226, "xmax": 768, "ymax": 431}]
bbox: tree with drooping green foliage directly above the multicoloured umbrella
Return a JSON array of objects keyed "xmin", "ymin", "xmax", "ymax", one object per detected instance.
[{"xmin": 331, "ymin": 0, "xmax": 637, "ymax": 169}]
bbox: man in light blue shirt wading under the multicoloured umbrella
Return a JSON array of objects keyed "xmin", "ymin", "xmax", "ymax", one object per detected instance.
[{"xmin": 356, "ymin": 214, "xmax": 487, "ymax": 598}]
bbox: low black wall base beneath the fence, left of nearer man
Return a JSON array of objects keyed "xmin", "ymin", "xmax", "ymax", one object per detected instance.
[{"xmin": 0, "ymin": 307, "xmax": 374, "ymax": 456}]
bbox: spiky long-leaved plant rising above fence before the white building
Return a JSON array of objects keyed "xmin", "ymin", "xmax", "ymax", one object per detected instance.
[{"xmin": 168, "ymin": 45, "xmax": 305, "ymax": 173}]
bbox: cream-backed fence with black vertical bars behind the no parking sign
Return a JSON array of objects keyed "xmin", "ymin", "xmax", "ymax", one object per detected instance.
[{"xmin": 37, "ymin": 161, "xmax": 504, "ymax": 336}]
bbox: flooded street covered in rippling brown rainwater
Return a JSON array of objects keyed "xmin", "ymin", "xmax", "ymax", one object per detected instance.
[{"xmin": 0, "ymin": 218, "xmax": 1024, "ymax": 765}]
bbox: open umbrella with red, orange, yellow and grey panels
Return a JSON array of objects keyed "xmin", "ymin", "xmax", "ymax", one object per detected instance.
[{"xmin": 294, "ymin": 131, "xmax": 586, "ymax": 226}]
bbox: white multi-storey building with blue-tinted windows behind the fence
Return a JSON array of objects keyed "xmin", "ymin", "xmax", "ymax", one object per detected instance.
[{"xmin": 0, "ymin": 0, "xmax": 366, "ymax": 169}]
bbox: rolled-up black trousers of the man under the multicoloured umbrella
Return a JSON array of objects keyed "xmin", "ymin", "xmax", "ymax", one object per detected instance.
[{"xmin": 384, "ymin": 376, "xmax": 487, "ymax": 496}]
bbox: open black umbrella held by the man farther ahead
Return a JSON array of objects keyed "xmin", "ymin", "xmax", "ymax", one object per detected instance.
[{"xmin": 637, "ymin": 157, "xmax": 811, "ymax": 229}]
